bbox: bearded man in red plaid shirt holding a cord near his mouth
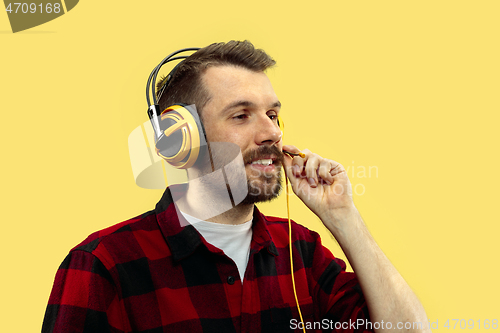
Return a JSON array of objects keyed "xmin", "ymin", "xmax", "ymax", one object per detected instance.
[{"xmin": 42, "ymin": 41, "xmax": 428, "ymax": 332}]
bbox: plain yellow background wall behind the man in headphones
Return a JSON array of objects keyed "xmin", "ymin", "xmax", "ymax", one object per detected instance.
[{"xmin": 0, "ymin": 0, "xmax": 500, "ymax": 332}]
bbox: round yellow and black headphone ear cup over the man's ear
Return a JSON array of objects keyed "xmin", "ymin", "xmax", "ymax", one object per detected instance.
[{"xmin": 156, "ymin": 104, "xmax": 206, "ymax": 169}]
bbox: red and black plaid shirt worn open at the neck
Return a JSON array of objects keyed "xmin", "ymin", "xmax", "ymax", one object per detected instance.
[{"xmin": 42, "ymin": 189, "xmax": 369, "ymax": 333}]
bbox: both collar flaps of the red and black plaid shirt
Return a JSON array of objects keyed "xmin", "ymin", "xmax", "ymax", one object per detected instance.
[{"xmin": 155, "ymin": 185, "xmax": 278, "ymax": 261}]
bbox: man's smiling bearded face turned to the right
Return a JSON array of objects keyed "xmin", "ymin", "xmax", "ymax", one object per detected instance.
[{"xmin": 202, "ymin": 66, "xmax": 283, "ymax": 203}]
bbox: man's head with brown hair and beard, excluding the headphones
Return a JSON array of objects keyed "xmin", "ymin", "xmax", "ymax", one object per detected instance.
[{"xmin": 158, "ymin": 41, "xmax": 283, "ymax": 204}]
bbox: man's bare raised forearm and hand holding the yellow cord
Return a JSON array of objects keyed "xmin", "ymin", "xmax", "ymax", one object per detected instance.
[{"xmin": 283, "ymin": 146, "xmax": 430, "ymax": 332}]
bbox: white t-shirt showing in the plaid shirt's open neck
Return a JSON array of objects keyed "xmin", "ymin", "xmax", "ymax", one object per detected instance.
[{"xmin": 181, "ymin": 212, "xmax": 252, "ymax": 283}]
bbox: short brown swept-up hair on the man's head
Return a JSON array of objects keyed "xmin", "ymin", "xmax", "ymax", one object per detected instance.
[{"xmin": 156, "ymin": 40, "xmax": 276, "ymax": 115}]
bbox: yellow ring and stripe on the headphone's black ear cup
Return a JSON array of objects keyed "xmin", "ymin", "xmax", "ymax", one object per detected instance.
[{"xmin": 156, "ymin": 105, "xmax": 200, "ymax": 169}]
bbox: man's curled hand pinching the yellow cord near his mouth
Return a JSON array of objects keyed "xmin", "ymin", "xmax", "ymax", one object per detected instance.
[{"xmin": 283, "ymin": 145, "xmax": 356, "ymax": 236}]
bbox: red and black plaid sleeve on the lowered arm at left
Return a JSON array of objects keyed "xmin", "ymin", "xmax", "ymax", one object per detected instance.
[{"xmin": 42, "ymin": 250, "xmax": 126, "ymax": 333}]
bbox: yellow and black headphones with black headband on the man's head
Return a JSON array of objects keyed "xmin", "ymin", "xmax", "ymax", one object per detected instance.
[{"xmin": 146, "ymin": 47, "xmax": 207, "ymax": 169}]
